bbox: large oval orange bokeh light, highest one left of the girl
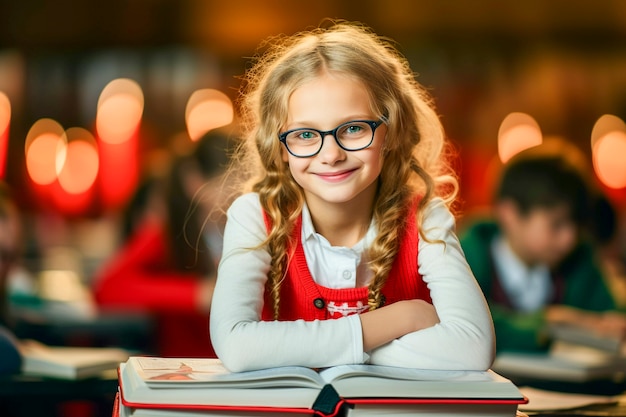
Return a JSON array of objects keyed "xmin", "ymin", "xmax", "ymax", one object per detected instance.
[{"xmin": 96, "ymin": 78, "xmax": 144, "ymax": 143}]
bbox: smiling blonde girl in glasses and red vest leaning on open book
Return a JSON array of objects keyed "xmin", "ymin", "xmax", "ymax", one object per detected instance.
[{"xmin": 211, "ymin": 23, "xmax": 494, "ymax": 371}]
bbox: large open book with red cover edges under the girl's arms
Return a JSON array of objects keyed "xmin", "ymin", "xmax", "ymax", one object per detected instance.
[{"xmin": 119, "ymin": 356, "xmax": 525, "ymax": 417}]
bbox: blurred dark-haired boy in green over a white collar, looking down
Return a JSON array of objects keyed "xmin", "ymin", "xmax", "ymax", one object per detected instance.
[{"xmin": 461, "ymin": 142, "xmax": 626, "ymax": 352}]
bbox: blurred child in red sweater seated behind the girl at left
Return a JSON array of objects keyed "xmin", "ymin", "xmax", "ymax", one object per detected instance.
[{"xmin": 94, "ymin": 128, "xmax": 232, "ymax": 357}]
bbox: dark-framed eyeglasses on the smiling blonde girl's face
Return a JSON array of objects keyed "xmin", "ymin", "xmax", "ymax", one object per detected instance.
[{"xmin": 278, "ymin": 118, "xmax": 385, "ymax": 158}]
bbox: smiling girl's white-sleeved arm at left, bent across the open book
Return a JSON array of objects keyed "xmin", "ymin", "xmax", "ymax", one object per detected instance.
[{"xmin": 210, "ymin": 194, "xmax": 364, "ymax": 371}]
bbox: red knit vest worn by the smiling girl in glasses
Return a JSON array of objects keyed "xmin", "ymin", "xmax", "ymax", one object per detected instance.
[{"xmin": 262, "ymin": 203, "xmax": 432, "ymax": 321}]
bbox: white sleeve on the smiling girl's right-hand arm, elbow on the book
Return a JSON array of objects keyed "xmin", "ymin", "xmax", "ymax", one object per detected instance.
[{"xmin": 370, "ymin": 200, "xmax": 495, "ymax": 370}]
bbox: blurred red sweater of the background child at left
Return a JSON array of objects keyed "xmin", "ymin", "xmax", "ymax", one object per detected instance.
[{"xmin": 93, "ymin": 221, "xmax": 215, "ymax": 357}]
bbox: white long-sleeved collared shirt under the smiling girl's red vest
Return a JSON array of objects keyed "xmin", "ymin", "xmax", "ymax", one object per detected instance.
[{"xmin": 210, "ymin": 193, "xmax": 495, "ymax": 371}]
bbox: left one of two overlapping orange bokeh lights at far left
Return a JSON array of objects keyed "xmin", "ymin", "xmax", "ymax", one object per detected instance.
[{"xmin": 24, "ymin": 119, "xmax": 67, "ymax": 185}]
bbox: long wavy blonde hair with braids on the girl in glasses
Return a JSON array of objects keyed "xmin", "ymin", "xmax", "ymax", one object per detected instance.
[{"xmin": 233, "ymin": 22, "xmax": 457, "ymax": 317}]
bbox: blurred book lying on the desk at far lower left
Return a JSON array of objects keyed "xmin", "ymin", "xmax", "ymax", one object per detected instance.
[{"xmin": 20, "ymin": 342, "xmax": 129, "ymax": 379}]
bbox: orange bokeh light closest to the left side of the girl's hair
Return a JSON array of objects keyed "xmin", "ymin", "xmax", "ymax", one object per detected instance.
[{"xmin": 185, "ymin": 88, "xmax": 234, "ymax": 141}]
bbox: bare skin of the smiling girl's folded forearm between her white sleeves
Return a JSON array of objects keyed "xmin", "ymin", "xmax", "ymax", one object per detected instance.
[{"xmin": 360, "ymin": 300, "xmax": 439, "ymax": 352}]
